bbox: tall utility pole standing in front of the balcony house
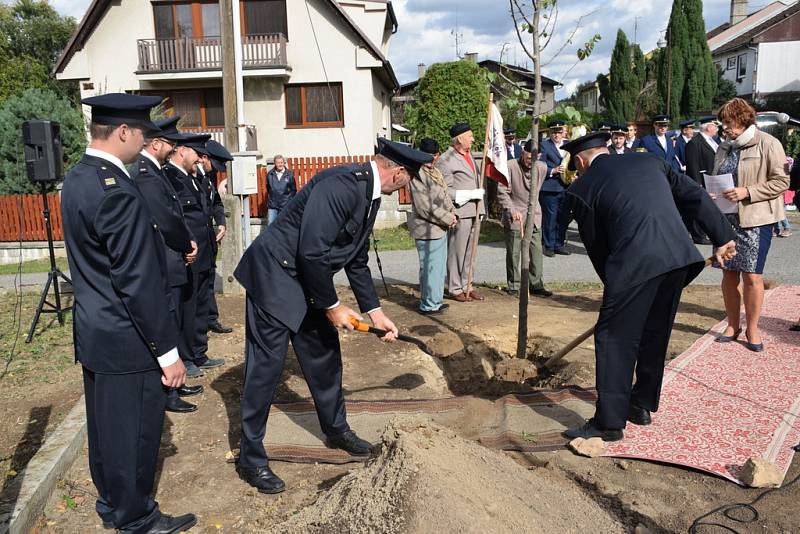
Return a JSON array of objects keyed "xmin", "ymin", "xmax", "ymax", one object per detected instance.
[{"xmin": 219, "ymin": 0, "xmax": 244, "ymax": 294}]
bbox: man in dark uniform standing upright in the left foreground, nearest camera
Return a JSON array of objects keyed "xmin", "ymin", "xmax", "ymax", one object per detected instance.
[{"xmin": 61, "ymin": 94, "xmax": 197, "ymax": 534}]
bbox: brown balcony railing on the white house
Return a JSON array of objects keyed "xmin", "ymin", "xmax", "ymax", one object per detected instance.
[{"xmin": 137, "ymin": 33, "xmax": 289, "ymax": 74}]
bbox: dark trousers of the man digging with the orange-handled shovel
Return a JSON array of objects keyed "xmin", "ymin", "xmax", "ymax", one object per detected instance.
[{"xmin": 239, "ymin": 297, "xmax": 350, "ymax": 467}]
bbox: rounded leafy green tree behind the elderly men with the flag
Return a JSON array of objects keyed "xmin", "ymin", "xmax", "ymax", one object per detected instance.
[{"xmin": 406, "ymin": 60, "xmax": 489, "ymax": 150}]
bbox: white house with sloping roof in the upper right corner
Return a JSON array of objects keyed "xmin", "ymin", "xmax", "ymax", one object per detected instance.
[{"xmin": 708, "ymin": 0, "xmax": 800, "ymax": 100}]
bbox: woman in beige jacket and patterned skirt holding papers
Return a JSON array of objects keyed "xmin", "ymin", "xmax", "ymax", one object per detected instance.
[{"xmin": 714, "ymin": 98, "xmax": 789, "ymax": 352}]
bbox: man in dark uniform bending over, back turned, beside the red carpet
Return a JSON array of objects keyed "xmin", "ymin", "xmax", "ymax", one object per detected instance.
[{"xmin": 565, "ymin": 133, "xmax": 736, "ymax": 441}]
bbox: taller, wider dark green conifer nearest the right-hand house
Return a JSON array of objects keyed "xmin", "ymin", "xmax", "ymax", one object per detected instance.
[{"xmin": 658, "ymin": 0, "xmax": 717, "ymax": 117}]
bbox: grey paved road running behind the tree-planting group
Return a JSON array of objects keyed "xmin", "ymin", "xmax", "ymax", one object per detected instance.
[{"xmin": 0, "ymin": 223, "xmax": 800, "ymax": 291}]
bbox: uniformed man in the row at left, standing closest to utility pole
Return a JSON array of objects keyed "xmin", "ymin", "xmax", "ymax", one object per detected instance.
[{"xmin": 197, "ymin": 139, "xmax": 233, "ymax": 334}]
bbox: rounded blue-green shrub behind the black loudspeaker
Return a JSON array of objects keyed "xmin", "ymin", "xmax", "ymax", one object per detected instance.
[{"xmin": 0, "ymin": 89, "xmax": 86, "ymax": 195}]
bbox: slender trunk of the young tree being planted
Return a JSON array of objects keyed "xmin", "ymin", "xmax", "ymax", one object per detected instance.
[{"xmin": 517, "ymin": 4, "xmax": 542, "ymax": 358}]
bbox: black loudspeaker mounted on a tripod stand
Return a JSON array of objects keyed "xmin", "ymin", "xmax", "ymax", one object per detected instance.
[{"xmin": 22, "ymin": 120, "xmax": 64, "ymax": 182}]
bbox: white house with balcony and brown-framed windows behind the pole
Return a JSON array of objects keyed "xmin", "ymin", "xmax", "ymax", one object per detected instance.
[{"xmin": 55, "ymin": 0, "xmax": 399, "ymax": 157}]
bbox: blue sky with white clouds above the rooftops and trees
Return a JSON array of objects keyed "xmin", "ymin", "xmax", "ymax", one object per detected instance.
[{"xmin": 31, "ymin": 0, "xmax": 736, "ymax": 98}]
